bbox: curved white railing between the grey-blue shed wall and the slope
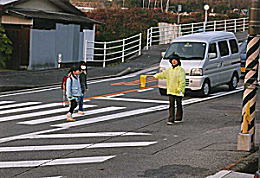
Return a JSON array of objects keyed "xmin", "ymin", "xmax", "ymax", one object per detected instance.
[{"xmin": 84, "ymin": 33, "xmax": 142, "ymax": 67}]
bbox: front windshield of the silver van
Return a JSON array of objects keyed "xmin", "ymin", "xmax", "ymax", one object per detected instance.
[{"xmin": 164, "ymin": 42, "xmax": 206, "ymax": 60}]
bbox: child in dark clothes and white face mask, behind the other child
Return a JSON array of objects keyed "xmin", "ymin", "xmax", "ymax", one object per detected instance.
[{"xmin": 78, "ymin": 61, "xmax": 88, "ymax": 115}]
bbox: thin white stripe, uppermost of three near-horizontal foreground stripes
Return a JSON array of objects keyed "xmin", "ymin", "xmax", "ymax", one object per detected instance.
[{"xmin": 24, "ymin": 132, "xmax": 151, "ymax": 139}]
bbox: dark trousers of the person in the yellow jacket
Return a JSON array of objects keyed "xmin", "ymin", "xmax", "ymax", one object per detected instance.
[{"xmin": 168, "ymin": 95, "xmax": 183, "ymax": 122}]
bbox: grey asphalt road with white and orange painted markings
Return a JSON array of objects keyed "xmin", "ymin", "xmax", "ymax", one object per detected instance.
[{"xmin": 0, "ymin": 68, "xmax": 259, "ymax": 178}]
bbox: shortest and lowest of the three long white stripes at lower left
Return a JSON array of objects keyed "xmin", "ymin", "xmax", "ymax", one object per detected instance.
[{"xmin": 0, "ymin": 155, "xmax": 115, "ymax": 168}]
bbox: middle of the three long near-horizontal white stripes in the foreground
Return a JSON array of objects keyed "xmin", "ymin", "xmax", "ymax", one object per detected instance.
[{"xmin": 0, "ymin": 141, "xmax": 157, "ymax": 152}]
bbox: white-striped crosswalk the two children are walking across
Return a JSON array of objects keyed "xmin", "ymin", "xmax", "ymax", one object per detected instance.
[{"xmin": 0, "ymin": 101, "xmax": 160, "ymax": 169}]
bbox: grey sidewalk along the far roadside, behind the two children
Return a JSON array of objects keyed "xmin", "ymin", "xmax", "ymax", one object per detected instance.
[{"xmin": 0, "ymin": 45, "xmax": 168, "ymax": 92}]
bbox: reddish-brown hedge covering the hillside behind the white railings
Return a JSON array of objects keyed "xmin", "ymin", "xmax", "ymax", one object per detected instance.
[{"xmin": 87, "ymin": 8, "xmax": 243, "ymax": 41}]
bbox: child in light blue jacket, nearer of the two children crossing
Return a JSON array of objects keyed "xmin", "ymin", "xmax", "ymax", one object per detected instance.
[{"xmin": 66, "ymin": 66, "xmax": 82, "ymax": 121}]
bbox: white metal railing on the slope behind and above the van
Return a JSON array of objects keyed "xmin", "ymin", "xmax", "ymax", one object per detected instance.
[{"xmin": 146, "ymin": 18, "xmax": 248, "ymax": 49}]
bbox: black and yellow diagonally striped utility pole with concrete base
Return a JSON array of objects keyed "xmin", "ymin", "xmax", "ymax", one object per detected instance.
[{"xmin": 237, "ymin": 0, "xmax": 260, "ymax": 151}]
